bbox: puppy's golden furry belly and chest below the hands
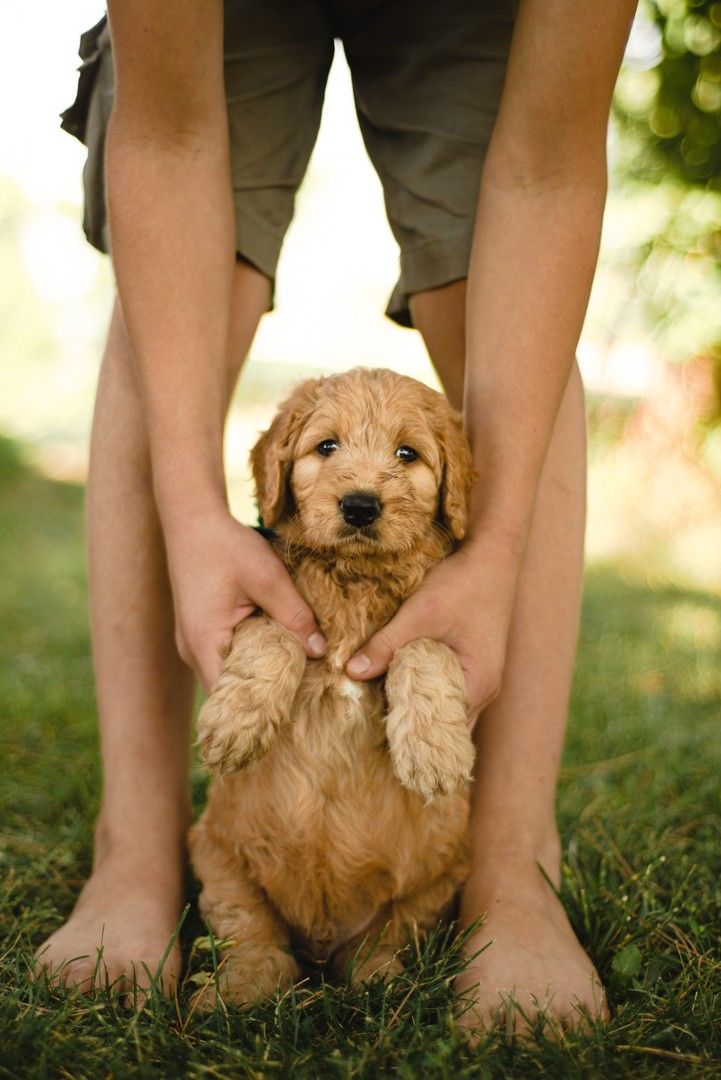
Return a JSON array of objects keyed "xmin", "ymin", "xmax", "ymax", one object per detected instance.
[{"xmin": 198, "ymin": 675, "xmax": 467, "ymax": 959}]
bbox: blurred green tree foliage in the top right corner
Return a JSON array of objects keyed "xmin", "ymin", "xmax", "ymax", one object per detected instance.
[{"xmin": 614, "ymin": 0, "xmax": 721, "ymax": 420}]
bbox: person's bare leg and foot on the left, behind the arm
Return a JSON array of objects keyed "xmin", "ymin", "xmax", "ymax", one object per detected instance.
[{"xmin": 38, "ymin": 264, "xmax": 270, "ymax": 989}]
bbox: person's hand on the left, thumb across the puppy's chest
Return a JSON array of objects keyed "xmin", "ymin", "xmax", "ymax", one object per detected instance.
[{"xmin": 165, "ymin": 509, "xmax": 326, "ymax": 690}]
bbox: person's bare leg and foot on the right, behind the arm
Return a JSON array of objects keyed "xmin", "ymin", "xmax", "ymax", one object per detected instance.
[{"xmin": 411, "ymin": 282, "xmax": 604, "ymax": 1027}]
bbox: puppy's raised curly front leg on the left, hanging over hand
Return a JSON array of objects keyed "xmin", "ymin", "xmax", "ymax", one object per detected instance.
[{"xmin": 198, "ymin": 615, "xmax": 305, "ymax": 772}]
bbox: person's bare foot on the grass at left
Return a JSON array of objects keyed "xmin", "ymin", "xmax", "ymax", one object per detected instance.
[{"xmin": 36, "ymin": 853, "xmax": 181, "ymax": 994}]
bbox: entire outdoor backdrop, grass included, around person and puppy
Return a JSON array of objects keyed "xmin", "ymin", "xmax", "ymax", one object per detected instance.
[{"xmin": 0, "ymin": 0, "xmax": 721, "ymax": 1080}]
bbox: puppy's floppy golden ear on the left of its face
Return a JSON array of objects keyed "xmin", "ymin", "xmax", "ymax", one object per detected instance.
[{"xmin": 250, "ymin": 379, "xmax": 322, "ymax": 528}]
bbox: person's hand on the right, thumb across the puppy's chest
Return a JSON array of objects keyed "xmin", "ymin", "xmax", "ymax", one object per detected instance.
[{"xmin": 345, "ymin": 536, "xmax": 518, "ymax": 721}]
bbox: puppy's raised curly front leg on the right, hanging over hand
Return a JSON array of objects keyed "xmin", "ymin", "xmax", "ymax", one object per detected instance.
[{"xmin": 385, "ymin": 637, "xmax": 474, "ymax": 800}]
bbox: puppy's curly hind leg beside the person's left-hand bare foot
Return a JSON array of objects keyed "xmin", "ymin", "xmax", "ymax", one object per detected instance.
[{"xmin": 190, "ymin": 821, "xmax": 300, "ymax": 1009}]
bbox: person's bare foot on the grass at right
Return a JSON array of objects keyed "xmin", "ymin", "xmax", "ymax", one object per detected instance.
[{"xmin": 455, "ymin": 867, "xmax": 609, "ymax": 1035}]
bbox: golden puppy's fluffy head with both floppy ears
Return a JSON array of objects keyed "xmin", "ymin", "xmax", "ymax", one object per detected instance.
[{"xmin": 251, "ymin": 368, "xmax": 473, "ymax": 555}]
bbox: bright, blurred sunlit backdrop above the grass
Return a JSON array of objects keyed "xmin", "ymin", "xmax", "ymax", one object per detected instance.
[{"xmin": 0, "ymin": 0, "xmax": 721, "ymax": 591}]
